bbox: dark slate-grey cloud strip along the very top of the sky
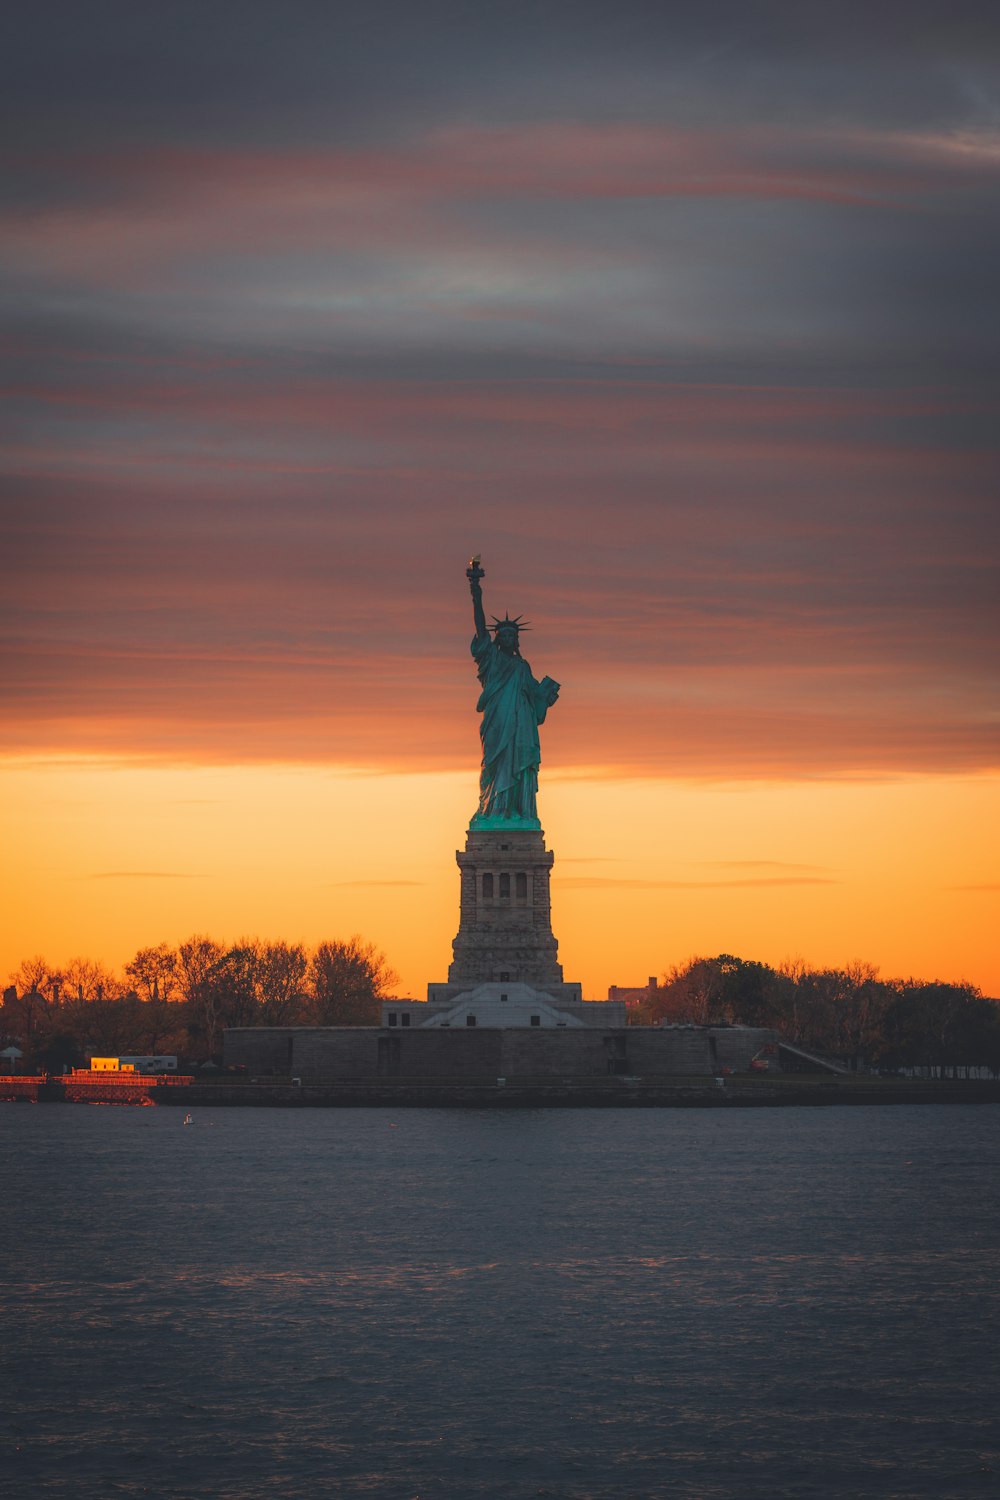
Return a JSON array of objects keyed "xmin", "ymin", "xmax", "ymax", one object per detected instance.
[{"xmin": 7, "ymin": 0, "xmax": 1000, "ymax": 141}]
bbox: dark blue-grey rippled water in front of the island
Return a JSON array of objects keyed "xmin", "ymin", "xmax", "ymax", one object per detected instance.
[{"xmin": 0, "ymin": 1104, "xmax": 1000, "ymax": 1500}]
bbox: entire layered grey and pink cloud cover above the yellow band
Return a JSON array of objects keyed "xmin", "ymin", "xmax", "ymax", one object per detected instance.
[{"xmin": 0, "ymin": 0, "xmax": 1000, "ymax": 774}]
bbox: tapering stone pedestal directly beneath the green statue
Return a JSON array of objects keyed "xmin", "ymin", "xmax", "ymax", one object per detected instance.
[{"xmin": 427, "ymin": 828, "xmax": 582, "ymax": 1002}]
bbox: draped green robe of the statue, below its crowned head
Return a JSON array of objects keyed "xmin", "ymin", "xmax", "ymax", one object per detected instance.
[{"xmin": 472, "ymin": 636, "xmax": 549, "ymax": 819}]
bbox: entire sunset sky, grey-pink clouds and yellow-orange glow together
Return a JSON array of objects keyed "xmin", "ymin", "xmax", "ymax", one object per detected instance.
[{"xmin": 0, "ymin": 0, "xmax": 1000, "ymax": 998}]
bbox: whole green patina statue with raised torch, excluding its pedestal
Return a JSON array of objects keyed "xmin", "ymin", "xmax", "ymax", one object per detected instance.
[{"xmin": 466, "ymin": 554, "xmax": 559, "ymax": 828}]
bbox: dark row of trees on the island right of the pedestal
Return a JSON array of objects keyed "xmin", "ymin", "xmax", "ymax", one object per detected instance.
[{"xmin": 628, "ymin": 954, "xmax": 1000, "ymax": 1077}]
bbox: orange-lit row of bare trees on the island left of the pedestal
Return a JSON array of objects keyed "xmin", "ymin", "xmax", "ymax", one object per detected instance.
[{"xmin": 0, "ymin": 935, "xmax": 397, "ymax": 1073}]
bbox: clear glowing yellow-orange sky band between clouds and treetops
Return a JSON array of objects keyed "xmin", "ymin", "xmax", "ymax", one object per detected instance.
[{"xmin": 0, "ymin": 758, "xmax": 1000, "ymax": 999}]
